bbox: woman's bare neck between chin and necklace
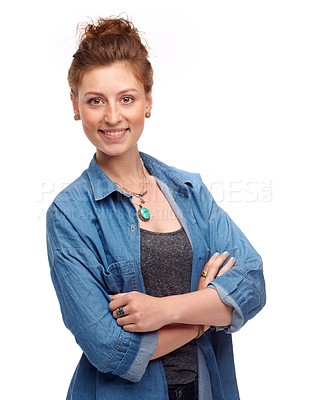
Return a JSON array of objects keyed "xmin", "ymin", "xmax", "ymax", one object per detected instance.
[{"xmin": 96, "ymin": 147, "xmax": 143, "ymax": 190}]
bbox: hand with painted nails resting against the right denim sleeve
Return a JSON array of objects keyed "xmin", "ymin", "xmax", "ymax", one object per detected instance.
[{"xmin": 197, "ymin": 251, "xmax": 235, "ymax": 290}]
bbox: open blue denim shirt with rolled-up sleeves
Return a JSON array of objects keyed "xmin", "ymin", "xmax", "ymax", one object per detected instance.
[{"xmin": 47, "ymin": 153, "xmax": 266, "ymax": 400}]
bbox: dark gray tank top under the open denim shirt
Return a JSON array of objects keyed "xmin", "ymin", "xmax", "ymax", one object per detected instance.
[{"xmin": 140, "ymin": 228, "xmax": 197, "ymax": 385}]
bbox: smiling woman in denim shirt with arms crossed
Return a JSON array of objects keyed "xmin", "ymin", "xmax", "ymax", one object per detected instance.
[{"xmin": 47, "ymin": 18, "xmax": 265, "ymax": 400}]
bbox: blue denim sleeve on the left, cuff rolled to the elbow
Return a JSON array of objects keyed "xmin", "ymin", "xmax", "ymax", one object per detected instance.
[{"xmin": 47, "ymin": 204, "xmax": 158, "ymax": 382}]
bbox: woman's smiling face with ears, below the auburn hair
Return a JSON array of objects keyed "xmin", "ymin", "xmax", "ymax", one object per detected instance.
[{"xmin": 71, "ymin": 62, "xmax": 152, "ymax": 158}]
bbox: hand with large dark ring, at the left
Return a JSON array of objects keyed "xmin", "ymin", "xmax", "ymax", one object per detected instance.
[{"xmin": 109, "ymin": 292, "xmax": 168, "ymax": 332}]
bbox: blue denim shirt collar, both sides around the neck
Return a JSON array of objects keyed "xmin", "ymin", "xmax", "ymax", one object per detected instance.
[{"xmin": 87, "ymin": 152, "xmax": 193, "ymax": 201}]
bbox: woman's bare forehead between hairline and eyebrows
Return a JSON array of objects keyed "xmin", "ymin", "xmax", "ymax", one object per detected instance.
[{"xmin": 79, "ymin": 63, "xmax": 144, "ymax": 93}]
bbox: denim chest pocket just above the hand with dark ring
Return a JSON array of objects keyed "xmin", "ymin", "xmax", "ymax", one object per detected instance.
[{"xmin": 103, "ymin": 260, "xmax": 137, "ymax": 294}]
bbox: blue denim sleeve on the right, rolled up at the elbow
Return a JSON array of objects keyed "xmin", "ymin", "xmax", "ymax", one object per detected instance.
[{"xmin": 194, "ymin": 177, "xmax": 266, "ymax": 333}]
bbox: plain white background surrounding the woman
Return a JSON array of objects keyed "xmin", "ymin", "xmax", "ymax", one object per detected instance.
[{"xmin": 0, "ymin": 0, "xmax": 309, "ymax": 400}]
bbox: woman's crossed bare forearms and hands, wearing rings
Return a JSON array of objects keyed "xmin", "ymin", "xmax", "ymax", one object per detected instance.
[{"xmin": 109, "ymin": 252, "xmax": 235, "ymax": 359}]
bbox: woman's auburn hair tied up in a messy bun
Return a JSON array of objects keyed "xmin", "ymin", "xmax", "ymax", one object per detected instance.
[{"xmin": 68, "ymin": 17, "xmax": 153, "ymax": 96}]
